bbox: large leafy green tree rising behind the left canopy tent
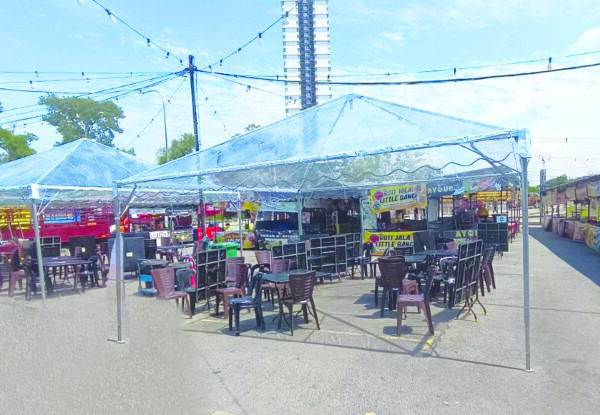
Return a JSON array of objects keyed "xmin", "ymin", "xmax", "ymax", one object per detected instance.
[{"xmin": 39, "ymin": 94, "xmax": 125, "ymax": 147}]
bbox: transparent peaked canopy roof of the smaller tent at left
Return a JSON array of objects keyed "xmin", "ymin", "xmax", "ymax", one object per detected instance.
[{"xmin": 0, "ymin": 138, "xmax": 153, "ymax": 205}]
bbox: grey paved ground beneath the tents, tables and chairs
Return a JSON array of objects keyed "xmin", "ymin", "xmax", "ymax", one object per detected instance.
[{"xmin": 0, "ymin": 227, "xmax": 600, "ymax": 415}]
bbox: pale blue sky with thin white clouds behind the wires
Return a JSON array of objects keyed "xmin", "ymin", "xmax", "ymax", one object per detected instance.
[{"xmin": 0, "ymin": 0, "xmax": 600, "ymax": 181}]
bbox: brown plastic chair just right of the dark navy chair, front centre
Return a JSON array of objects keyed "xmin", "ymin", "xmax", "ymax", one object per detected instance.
[{"xmin": 279, "ymin": 271, "xmax": 321, "ymax": 336}]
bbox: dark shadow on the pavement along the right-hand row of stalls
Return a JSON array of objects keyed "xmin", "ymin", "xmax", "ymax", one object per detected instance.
[{"xmin": 529, "ymin": 227, "xmax": 600, "ymax": 285}]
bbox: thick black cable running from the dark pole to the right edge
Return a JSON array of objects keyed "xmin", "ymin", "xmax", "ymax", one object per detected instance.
[{"xmin": 196, "ymin": 62, "xmax": 600, "ymax": 86}]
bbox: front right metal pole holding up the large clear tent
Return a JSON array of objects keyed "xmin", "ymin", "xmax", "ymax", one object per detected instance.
[{"xmin": 521, "ymin": 156, "xmax": 532, "ymax": 372}]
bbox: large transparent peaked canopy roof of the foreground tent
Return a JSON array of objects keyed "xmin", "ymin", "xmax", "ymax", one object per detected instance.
[{"xmin": 118, "ymin": 94, "xmax": 527, "ymax": 205}]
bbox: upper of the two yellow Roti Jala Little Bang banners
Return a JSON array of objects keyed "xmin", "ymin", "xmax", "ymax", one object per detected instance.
[{"xmin": 369, "ymin": 184, "xmax": 427, "ymax": 213}]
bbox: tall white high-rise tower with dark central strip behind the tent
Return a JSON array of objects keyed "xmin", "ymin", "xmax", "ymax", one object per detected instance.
[{"xmin": 281, "ymin": 0, "xmax": 331, "ymax": 115}]
